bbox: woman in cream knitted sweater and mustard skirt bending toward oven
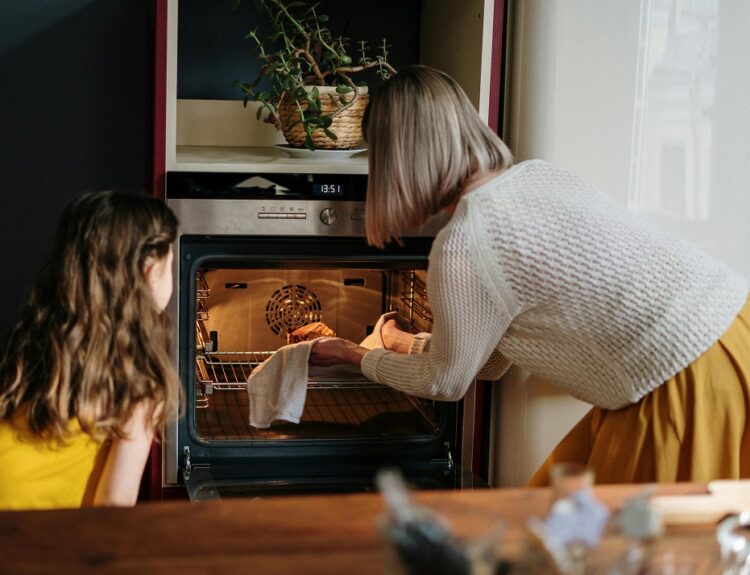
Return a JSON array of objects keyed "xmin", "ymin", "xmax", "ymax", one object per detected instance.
[{"xmin": 311, "ymin": 66, "xmax": 750, "ymax": 485}]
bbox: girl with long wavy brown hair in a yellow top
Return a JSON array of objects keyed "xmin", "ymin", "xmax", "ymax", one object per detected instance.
[{"xmin": 0, "ymin": 192, "xmax": 180, "ymax": 509}]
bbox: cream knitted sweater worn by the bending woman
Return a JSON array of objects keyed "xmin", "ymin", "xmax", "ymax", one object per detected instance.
[{"xmin": 362, "ymin": 160, "xmax": 748, "ymax": 409}]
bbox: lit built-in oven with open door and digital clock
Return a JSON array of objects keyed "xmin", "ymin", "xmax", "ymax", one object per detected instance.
[{"xmin": 162, "ymin": 172, "xmax": 482, "ymax": 501}]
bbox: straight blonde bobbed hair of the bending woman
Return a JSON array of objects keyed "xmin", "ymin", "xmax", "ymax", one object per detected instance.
[{"xmin": 365, "ymin": 66, "xmax": 513, "ymax": 247}]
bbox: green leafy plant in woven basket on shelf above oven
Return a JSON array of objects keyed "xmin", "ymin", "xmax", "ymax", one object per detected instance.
[{"xmin": 234, "ymin": 0, "xmax": 396, "ymax": 150}]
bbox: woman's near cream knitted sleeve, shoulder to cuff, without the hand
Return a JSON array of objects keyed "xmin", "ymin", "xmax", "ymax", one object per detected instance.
[{"xmin": 362, "ymin": 218, "xmax": 512, "ymax": 401}]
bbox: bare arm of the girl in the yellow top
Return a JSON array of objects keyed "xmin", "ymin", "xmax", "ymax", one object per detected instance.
[{"xmin": 94, "ymin": 402, "xmax": 154, "ymax": 507}]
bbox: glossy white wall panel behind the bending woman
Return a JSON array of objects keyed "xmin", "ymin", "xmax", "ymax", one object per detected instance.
[{"xmin": 493, "ymin": 0, "xmax": 750, "ymax": 485}]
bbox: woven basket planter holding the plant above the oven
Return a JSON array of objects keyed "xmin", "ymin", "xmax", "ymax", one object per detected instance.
[{"xmin": 278, "ymin": 86, "xmax": 369, "ymax": 150}]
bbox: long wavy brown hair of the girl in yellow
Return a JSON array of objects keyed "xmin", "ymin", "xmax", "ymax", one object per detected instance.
[{"xmin": 0, "ymin": 191, "xmax": 180, "ymax": 439}]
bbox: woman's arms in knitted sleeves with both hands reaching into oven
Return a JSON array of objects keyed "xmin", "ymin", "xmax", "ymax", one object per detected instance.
[{"xmin": 310, "ymin": 222, "xmax": 518, "ymax": 401}]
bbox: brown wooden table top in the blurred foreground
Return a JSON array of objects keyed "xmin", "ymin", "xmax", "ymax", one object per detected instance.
[{"xmin": 0, "ymin": 484, "xmax": 718, "ymax": 575}]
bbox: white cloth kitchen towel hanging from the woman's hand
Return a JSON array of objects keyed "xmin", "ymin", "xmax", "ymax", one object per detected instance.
[{"xmin": 247, "ymin": 340, "xmax": 315, "ymax": 429}]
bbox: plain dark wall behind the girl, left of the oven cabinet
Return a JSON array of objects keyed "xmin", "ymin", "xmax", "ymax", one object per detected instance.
[{"xmin": 0, "ymin": 0, "xmax": 153, "ymax": 333}]
